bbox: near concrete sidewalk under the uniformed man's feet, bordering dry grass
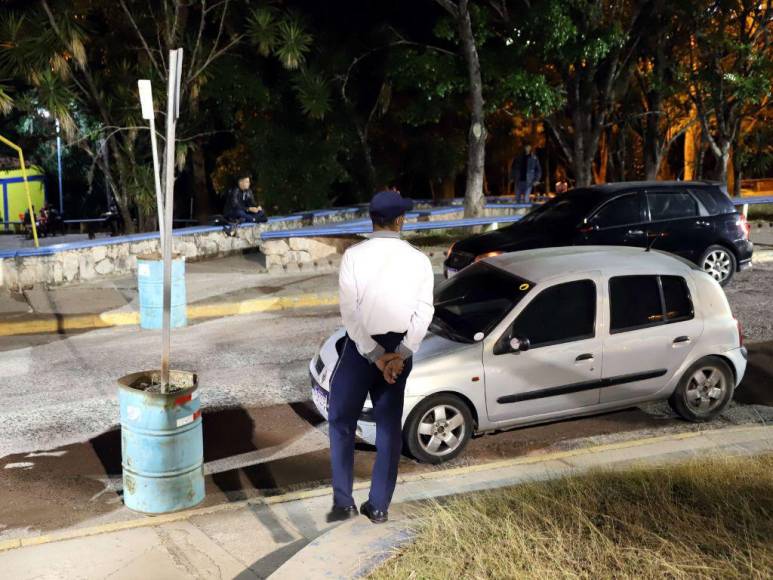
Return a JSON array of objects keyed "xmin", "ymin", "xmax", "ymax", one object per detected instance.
[{"xmin": 0, "ymin": 426, "xmax": 773, "ymax": 580}]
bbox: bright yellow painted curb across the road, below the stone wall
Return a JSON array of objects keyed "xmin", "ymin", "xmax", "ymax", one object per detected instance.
[{"xmin": 0, "ymin": 292, "xmax": 338, "ymax": 336}]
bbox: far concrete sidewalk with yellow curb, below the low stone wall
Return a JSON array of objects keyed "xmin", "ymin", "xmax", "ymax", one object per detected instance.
[{"xmin": 0, "ymin": 248, "xmax": 452, "ymax": 336}]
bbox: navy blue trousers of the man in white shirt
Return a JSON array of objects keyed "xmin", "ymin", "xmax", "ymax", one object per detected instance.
[{"xmin": 328, "ymin": 333, "xmax": 413, "ymax": 511}]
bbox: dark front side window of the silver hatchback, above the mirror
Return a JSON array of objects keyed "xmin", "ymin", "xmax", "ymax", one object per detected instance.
[{"xmin": 510, "ymin": 280, "xmax": 596, "ymax": 348}]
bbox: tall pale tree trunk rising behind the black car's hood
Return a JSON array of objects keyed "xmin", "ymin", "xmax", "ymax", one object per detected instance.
[{"xmin": 458, "ymin": 0, "xmax": 487, "ymax": 217}]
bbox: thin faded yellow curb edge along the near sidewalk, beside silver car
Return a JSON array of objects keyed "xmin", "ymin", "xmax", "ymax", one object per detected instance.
[{"xmin": 0, "ymin": 425, "xmax": 773, "ymax": 553}]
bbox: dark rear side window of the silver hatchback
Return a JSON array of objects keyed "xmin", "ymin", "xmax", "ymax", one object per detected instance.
[{"xmin": 609, "ymin": 276, "xmax": 694, "ymax": 334}]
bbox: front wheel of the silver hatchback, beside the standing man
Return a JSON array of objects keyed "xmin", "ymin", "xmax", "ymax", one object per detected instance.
[{"xmin": 403, "ymin": 393, "xmax": 475, "ymax": 464}]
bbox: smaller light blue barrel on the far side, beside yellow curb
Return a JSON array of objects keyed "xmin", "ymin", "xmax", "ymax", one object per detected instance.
[{"xmin": 137, "ymin": 255, "xmax": 188, "ymax": 330}]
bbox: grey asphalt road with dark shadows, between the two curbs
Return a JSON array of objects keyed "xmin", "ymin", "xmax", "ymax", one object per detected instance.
[{"xmin": 0, "ymin": 269, "xmax": 773, "ymax": 539}]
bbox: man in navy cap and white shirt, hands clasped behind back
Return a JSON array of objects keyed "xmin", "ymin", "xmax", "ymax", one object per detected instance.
[{"xmin": 328, "ymin": 190, "xmax": 434, "ymax": 523}]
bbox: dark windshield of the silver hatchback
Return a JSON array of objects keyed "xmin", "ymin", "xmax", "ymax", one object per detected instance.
[{"xmin": 430, "ymin": 262, "xmax": 533, "ymax": 342}]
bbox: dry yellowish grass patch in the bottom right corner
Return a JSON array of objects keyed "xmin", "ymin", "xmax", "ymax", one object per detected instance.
[{"xmin": 372, "ymin": 456, "xmax": 773, "ymax": 579}]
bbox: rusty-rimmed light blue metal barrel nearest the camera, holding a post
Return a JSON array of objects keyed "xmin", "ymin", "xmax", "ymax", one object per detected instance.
[{"xmin": 118, "ymin": 371, "xmax": 204, "ymax": 514}]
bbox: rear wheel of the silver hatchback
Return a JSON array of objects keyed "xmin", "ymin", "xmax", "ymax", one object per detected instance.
[{"xmin": 668, "ymin": 356, "xmax": 735, "ymax": 423}]
